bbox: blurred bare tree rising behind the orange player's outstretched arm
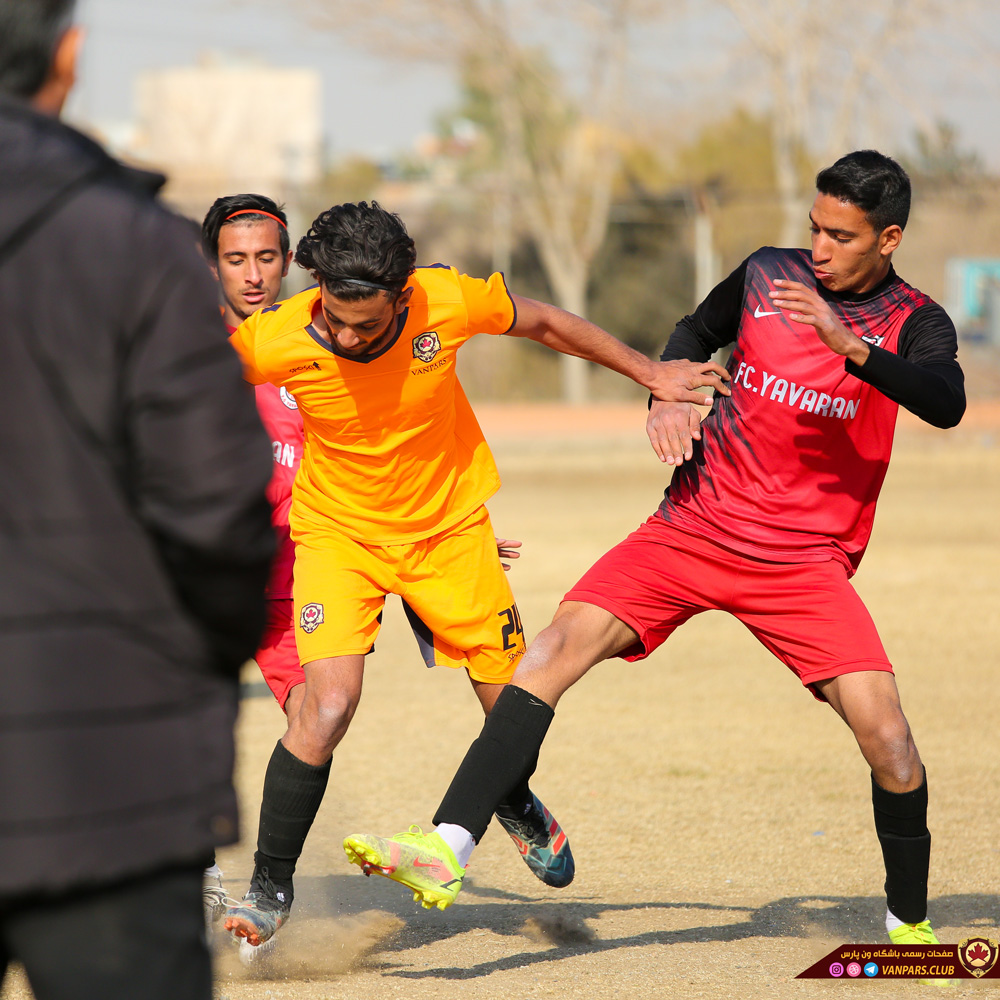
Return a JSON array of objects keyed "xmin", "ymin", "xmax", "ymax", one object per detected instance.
[{"xmin": 292, "ymin": 0, "xmax": 664, "ymax": 403}]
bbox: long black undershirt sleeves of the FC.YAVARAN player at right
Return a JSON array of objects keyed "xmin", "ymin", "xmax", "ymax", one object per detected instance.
[{"xmin": 660, "ymin": 261, "xmax": 965, "ymax": 427}]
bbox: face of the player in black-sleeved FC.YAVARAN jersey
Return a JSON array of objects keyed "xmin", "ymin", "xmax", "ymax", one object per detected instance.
[{"xmin": 809, "ymin": 194, "xmax": 902, "ymax": 294}]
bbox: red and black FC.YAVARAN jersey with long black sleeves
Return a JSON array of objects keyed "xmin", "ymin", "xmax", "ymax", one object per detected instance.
[{"xmin": 659, "ymin": 247, "xmax": 964, "ymax": 573}]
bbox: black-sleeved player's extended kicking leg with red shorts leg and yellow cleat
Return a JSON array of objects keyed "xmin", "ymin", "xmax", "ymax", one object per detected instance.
[{"xmin": 345, "ymin": 517, "xmax": 712, "ymax": 909}]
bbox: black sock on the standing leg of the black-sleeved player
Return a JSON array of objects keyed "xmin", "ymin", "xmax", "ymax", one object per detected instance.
[{"xmin": 872, "ymin": 771, "xmax": 931, "ymax": 924}]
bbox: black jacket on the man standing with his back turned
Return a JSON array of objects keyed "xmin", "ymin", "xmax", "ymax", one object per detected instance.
[{"xmin": 0, "ymin": 101, "xmax": 273, "ymax": 898}]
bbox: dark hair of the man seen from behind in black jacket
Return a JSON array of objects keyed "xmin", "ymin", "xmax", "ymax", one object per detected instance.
[{"xmin": 0, "ymin": 0, "xmax": 76, "ymax": 98}]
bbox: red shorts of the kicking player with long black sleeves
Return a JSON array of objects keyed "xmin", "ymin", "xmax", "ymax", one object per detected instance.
[{"xmin": 563, "ymin": 514, "xmax": 892, "ymax": 685}]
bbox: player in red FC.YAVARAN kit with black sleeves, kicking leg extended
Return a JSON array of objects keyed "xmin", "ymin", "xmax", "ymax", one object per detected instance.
[{"xmin": 354, "ymin": 150, "xmax": 965, "ymax": 944}]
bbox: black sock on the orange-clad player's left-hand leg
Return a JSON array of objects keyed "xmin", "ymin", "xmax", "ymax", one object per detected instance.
[{"xmin": 254, "ymin": 740, "xmax": 331, "ymax": 901}]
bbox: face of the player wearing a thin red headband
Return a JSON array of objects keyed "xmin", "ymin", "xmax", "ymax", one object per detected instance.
[{"xmin": 212, "ymin": 219, "xmax": 292, "ymax": 326}]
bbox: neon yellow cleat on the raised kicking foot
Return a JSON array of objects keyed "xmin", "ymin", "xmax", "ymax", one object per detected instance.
[{"xmin": 344, "ymin": 826, "xmax": 465, "ymax": 910}]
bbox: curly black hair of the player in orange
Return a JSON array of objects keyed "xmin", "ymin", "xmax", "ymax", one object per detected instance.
[{"xmin": 295, "ymin": 201, "xmax": 417, "ymax": 302}]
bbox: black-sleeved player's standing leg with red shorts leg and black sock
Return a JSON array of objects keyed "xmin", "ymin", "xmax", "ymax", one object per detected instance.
[{"xmin": 738, "ymin": 562, "xmax": 933, "ymax": 956}]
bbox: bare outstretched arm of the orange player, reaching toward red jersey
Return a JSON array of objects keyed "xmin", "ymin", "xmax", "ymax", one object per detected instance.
[{"xmin": 510, "ymin": 295, "xmax": 729, "ymax": 406}]
